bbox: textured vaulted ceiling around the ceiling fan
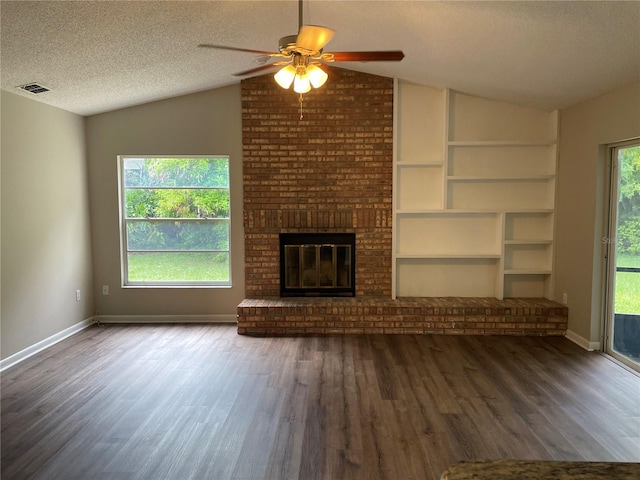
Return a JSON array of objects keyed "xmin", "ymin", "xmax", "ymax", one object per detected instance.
[{"xmin": 0, "ymin": 0, "xmax": 640, "ymax": 115}]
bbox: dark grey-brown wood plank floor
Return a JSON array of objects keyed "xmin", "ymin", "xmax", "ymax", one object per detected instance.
[{"xmin": 1, "ymin": 325, "xmax": 640, "ymax": 480}]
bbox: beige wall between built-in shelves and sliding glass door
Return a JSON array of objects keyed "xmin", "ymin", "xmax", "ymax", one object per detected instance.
[{"xmin": 555, "ymin": 83, "xmax": 640, "ymax": 346}]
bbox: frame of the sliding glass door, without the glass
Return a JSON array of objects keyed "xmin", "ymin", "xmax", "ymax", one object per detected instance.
[{"xmin": 602, "ymin": 138, "xmax": 640, "ymax": 371}]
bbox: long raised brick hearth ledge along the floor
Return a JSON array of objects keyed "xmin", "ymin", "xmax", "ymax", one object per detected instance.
[{"xmin": 238, "ymin": 297, "xmax": 569, "ymax": 336}]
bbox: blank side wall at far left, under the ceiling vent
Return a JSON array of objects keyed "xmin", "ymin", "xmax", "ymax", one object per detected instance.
[{"xmin": 0, "ymin": 91, "xmax": 94, "ymax": 359}]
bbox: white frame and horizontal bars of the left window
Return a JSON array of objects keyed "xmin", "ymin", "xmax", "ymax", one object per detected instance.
[{"xmin": 117, "ymin": 155, "xmax": 232, "ymax": 288}]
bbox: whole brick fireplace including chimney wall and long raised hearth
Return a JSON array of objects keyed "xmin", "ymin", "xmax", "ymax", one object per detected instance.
[{"xmin": 238, "ymin": 68, "xmax": 568, "ymax": 335}]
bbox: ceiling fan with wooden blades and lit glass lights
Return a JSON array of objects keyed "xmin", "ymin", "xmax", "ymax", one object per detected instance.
[{"xmin": 198, "ymin": 0, "xmax": 404, "ymax": 95}]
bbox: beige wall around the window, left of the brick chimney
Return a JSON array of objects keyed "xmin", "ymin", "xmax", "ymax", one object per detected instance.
[{"xmin": 86, "ymin": 85, "xmax": 244, "ymax": 320}]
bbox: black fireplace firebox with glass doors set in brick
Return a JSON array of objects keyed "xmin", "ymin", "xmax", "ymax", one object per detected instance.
[{"xmin": 280, "ymin": 233, "xmax": 356, "ymax": 297}]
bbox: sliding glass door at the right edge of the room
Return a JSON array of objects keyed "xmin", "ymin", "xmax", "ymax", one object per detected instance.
[{"xmin": 605, "ymin": 139, "xmax": 640, "ymax": 370}]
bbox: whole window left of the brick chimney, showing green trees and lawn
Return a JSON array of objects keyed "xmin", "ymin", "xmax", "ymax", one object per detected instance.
[{"xmin": 118, "ymin": 156, "xmax": 231, "ymax": 286}]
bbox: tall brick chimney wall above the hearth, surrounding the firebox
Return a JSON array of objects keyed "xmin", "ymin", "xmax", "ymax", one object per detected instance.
[{"xmin": 242, "ymin": 68, "xmax": 393, "ymax": 299}]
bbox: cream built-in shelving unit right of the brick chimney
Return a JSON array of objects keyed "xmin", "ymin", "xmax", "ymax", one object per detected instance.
[{"xmin": 392, "ymin": 81, "xmax": 557, "ymax": 298}]
